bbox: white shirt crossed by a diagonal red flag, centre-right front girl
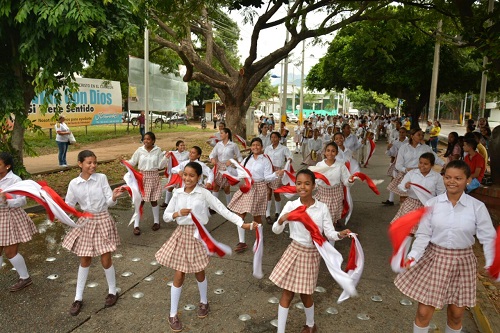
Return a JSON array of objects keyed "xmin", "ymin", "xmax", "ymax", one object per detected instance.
[{"xmin": 273, "ymin": 198, "xmax": 340, "ymax": 247}]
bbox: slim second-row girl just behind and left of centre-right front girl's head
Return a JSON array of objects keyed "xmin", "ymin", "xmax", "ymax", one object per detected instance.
[{"xmin": 264, "ymin": 132, "xmax": 292, "ymax": 224}]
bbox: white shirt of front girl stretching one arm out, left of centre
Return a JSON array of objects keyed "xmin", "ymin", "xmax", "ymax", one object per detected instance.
[{"xmin": 163, "ymin": 185, "xmax": 243, "ymax": 227}]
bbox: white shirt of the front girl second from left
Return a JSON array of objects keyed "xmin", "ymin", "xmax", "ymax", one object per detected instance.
[{"xmin": 64, "ymin": 173, "xmax": 116, "ymax": 213}]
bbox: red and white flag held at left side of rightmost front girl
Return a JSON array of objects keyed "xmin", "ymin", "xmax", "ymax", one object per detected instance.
[{"xmin": 389, "ymin": 207, "xmax": 429, "ymax": 273}]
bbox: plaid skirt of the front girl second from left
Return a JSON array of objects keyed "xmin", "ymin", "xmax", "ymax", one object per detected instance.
[{"xmin": 62, "ymin": 211, "xmax": 120, "ymax": 257}]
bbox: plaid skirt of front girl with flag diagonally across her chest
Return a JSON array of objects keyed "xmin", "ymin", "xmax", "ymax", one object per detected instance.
[{"xmin": 269, "ymin": 241, "xmax": 321, "ymax": 295}]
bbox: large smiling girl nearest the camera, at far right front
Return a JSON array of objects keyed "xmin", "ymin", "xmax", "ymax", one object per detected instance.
[{"xmin": 394, "ymin": 160, "xmax": 496, "ymax": 333}]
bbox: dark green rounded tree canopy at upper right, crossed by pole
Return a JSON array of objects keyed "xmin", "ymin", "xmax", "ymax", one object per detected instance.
[{"xmin": 306, "ymin": 11, "xmax": 492, "ymax": 124}]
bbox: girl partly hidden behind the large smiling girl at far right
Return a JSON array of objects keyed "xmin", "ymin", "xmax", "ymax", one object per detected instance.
[{"xmin": 391, "ymin": 152, "xmax": 446, "ymax": 234}]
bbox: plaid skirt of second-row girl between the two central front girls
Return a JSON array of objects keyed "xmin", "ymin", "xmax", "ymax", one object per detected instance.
[{"xmin": 227, "ymin": 182, "xmax": 267, "ymax": 216}]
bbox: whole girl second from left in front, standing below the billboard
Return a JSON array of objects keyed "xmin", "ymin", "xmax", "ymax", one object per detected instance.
[{"xmin": 62, "ymin": 149, "xmax": 125, "ymax": 316}]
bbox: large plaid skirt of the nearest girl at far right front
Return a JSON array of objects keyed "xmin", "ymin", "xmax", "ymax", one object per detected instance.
[{"xmin": 394, "ymin": 243, "xmax": 477, "ymax": 309}]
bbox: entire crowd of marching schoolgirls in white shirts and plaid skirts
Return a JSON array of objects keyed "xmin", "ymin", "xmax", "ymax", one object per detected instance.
[{"xmin": 0, "ymin": 115, "xmax": 495, "ymax": 333}]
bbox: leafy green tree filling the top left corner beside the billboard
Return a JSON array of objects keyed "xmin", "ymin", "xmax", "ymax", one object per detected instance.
[{"xmin": 0, "ymin": 0, "xmax": 143, "ymax": 171}]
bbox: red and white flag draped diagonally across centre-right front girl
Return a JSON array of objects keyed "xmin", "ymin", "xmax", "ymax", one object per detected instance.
[{"xmin": 288, "ymin": 206, "xmax": 357, "ymax": 297}]
